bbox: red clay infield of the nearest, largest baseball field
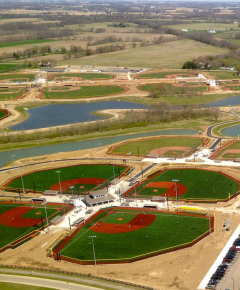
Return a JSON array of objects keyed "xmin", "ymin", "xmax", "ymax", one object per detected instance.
[{"xmin": 91, "ymin": 214, "xmax": 156, "ymax": 234}]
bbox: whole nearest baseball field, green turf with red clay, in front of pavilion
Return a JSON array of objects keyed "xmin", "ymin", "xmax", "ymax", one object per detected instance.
[{"xmin": 53, "ymin": 208, "xmax": 214, "ymax": 264}]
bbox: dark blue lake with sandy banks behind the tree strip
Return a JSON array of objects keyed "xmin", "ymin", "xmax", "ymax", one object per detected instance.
[{"xmin": 10, "ymin": 101, "xmax": 148, "ymax": 130}]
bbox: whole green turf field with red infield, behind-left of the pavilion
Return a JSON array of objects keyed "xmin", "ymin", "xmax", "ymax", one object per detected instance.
[{"xmin": 3, "ymin": 164, "xmax": 128, "ymax": 194}]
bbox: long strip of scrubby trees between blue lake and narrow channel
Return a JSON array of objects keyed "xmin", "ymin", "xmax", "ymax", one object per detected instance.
[{"xmin": 0, "ymin": 102, "xmax": 218, "ymax": 144}]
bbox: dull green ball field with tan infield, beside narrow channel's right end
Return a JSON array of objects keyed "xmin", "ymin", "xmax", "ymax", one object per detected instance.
[{"xmin": 108, "ymin": 137, "xmax": 202, "ymax": 157}]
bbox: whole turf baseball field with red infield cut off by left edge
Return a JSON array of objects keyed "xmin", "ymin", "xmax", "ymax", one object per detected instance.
[{"xmin": 0, "ymin": 202, "xmax": 73, "ymax": 252}]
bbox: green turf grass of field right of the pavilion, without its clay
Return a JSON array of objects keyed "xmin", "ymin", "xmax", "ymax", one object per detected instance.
[{"xmin": 128, "ymin": 169, "xmax": 239, "ymax": 200}]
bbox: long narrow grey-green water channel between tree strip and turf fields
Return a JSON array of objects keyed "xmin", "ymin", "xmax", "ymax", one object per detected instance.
[{"xmin": 0, "ymin": 129, "xmax": 198, "ymax": 167}]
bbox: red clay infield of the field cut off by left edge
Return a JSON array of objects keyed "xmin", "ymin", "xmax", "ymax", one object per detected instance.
[{"xmin": 0, "ymin": 206, "xmax": 41, "ymax": 227}]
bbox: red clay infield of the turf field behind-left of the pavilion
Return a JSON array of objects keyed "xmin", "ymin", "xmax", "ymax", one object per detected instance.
[{"xmin": 50, "ymin": 177, "xmax": 106, "ymax": 191}]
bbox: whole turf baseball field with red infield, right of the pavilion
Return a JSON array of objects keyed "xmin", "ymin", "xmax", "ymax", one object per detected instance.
[{"xmin": 124, "ymin": 168, "xmax": 240, "ymax": 202}]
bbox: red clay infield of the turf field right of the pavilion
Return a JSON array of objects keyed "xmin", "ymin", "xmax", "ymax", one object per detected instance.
[{"xmin": 146, "ymin": 181, "xmax": 187, "ymax": 197}]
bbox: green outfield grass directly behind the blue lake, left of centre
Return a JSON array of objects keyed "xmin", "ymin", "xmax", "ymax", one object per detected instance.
[{"xmin": 43, "ymin": 86, "xmax": 125, "ymax": 99}]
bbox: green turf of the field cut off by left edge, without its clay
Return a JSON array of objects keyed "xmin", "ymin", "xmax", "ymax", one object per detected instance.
[{"xmin": 0, "ymin": 203, "xmax": 69, "ymax": 249}]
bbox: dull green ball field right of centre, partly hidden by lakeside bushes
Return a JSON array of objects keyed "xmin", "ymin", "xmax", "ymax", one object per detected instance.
[{"xmin": 140, "ymin": 83, "xmax": 207, "ymax": 94}]
